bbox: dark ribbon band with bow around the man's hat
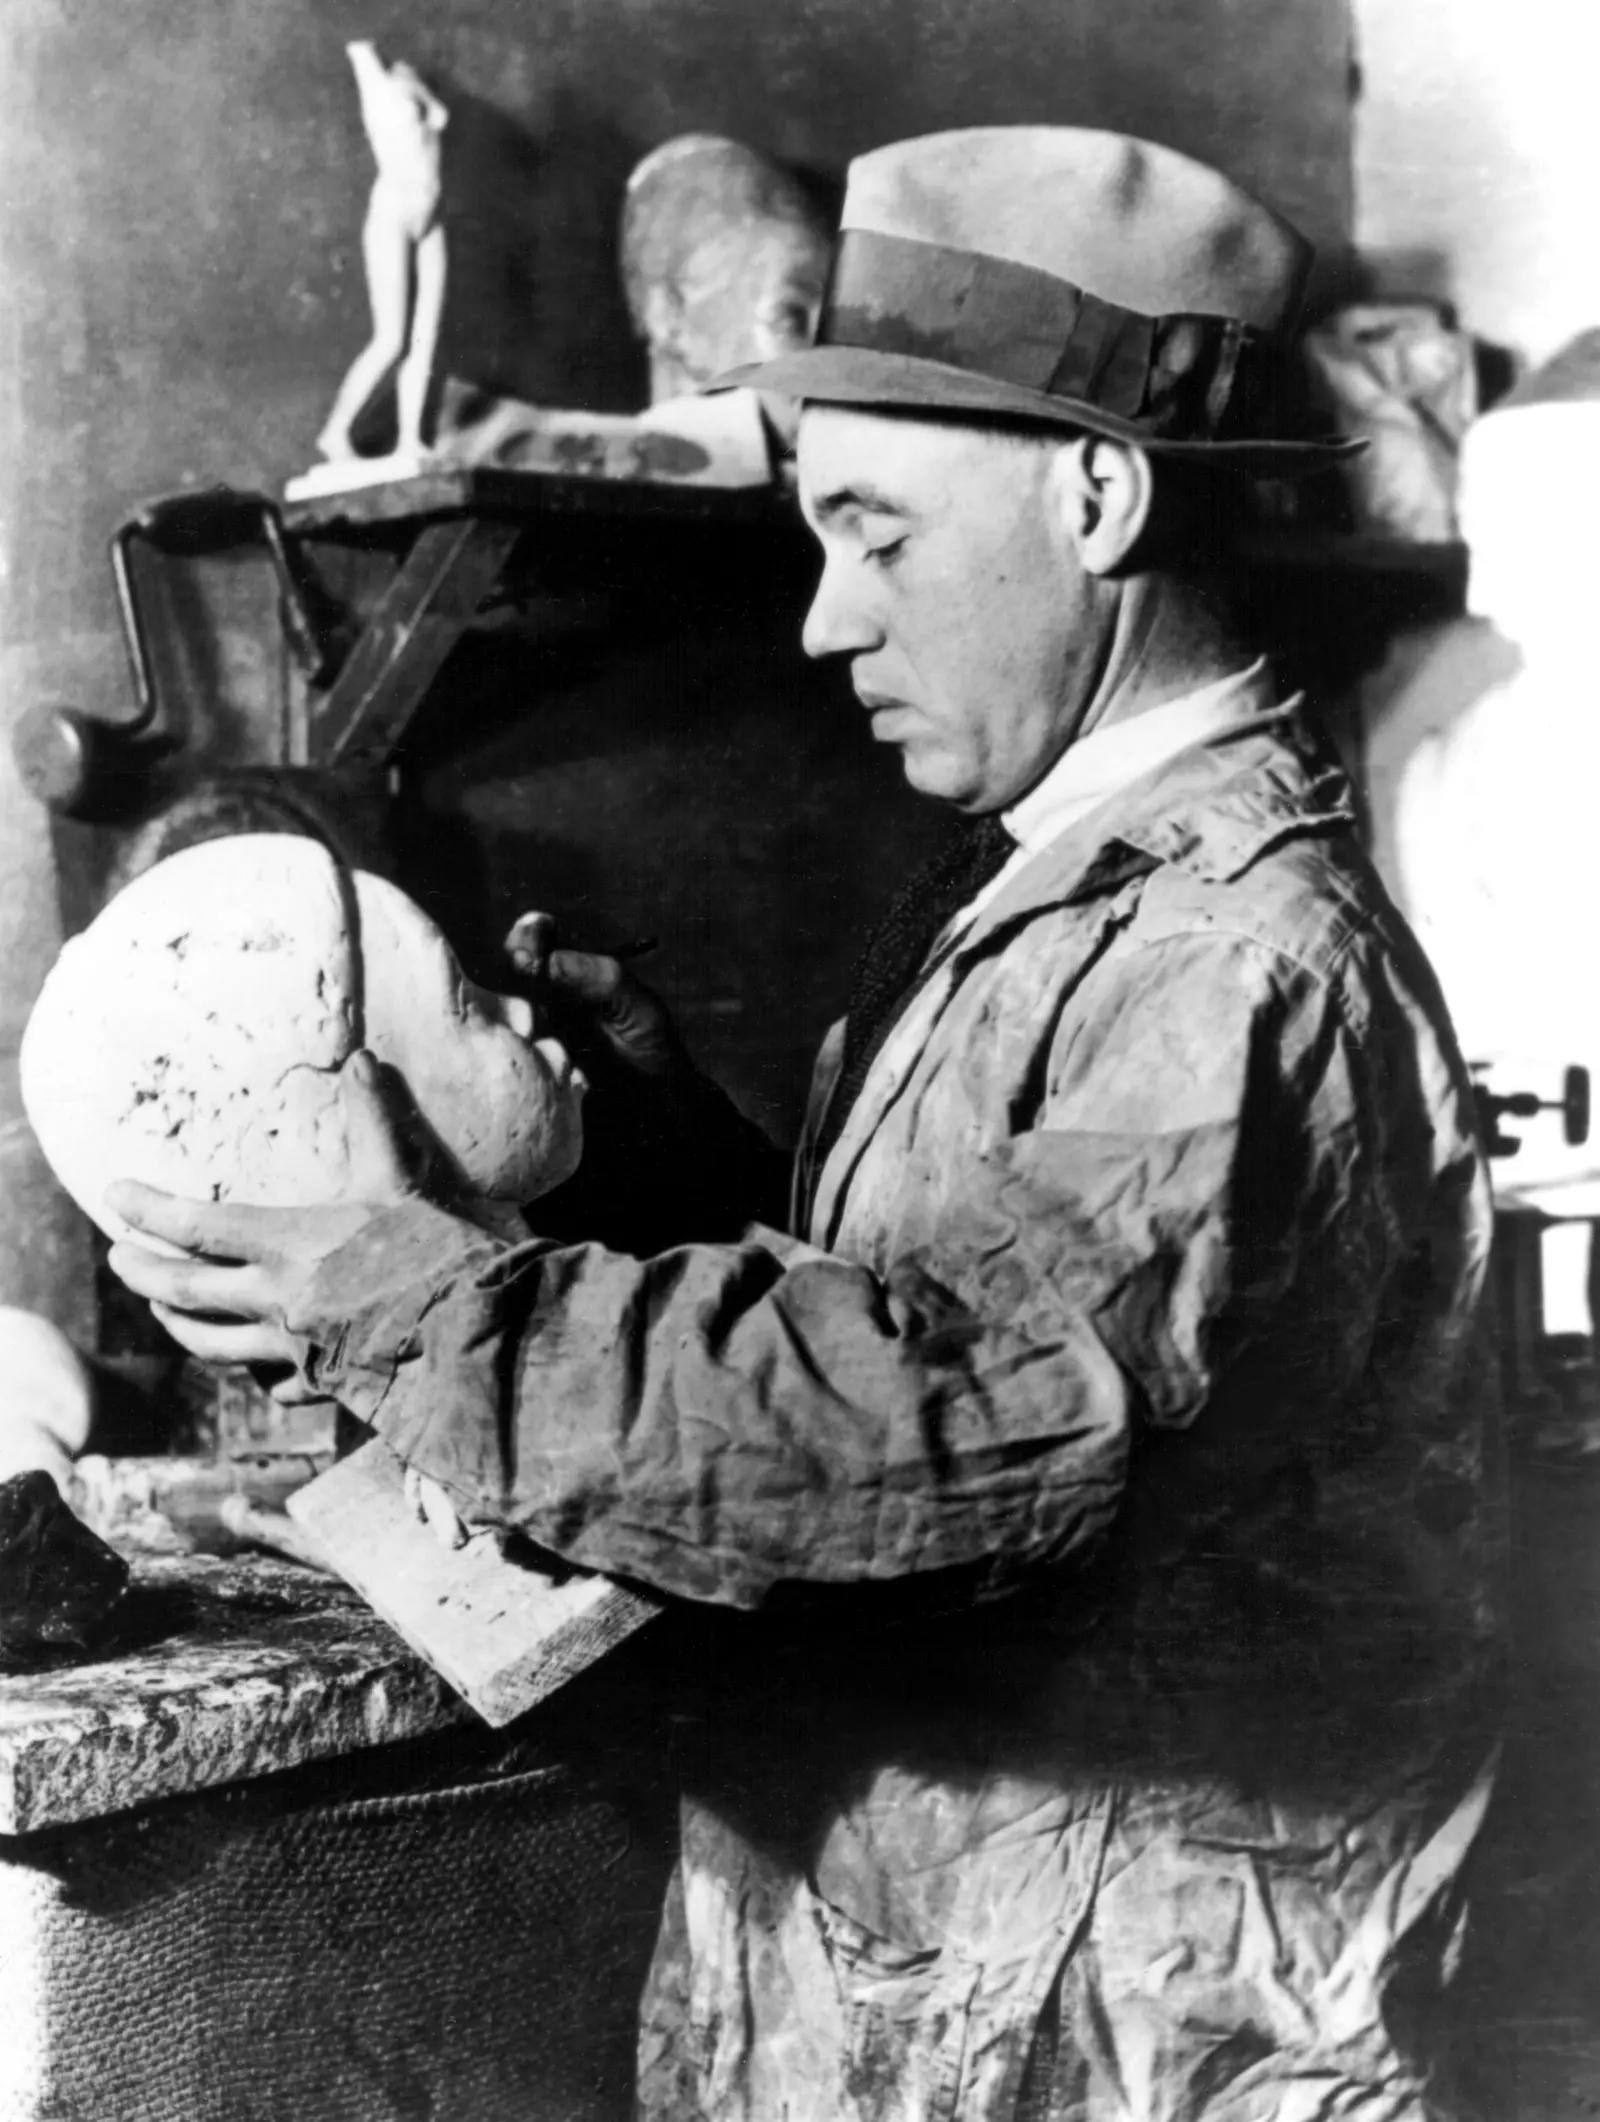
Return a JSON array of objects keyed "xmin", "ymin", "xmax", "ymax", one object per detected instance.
[{"xmin": 815, "ymin": 229, "xmax": 1275, "ymax": 441}]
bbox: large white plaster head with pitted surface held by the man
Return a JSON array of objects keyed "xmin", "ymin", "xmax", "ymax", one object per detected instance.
[{"xmin": 21, "ymin": 834, "xmax": 584, "ymax": 1246}]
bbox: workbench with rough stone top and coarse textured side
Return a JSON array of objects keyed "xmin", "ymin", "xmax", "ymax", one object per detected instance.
[{"xmin": 0, "ymin": 1555, "xmax": 671, "ymax": 2122}]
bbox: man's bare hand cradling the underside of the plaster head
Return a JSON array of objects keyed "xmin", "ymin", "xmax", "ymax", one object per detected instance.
[{"xmin": 106, "ymin": 1050, "xmax": 424, "ymax": 1401}]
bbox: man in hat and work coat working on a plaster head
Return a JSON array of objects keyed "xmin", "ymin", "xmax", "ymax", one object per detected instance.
[{"xmin": 117, "ymin": 127, "xmax": 1494, "ymax": 2122}]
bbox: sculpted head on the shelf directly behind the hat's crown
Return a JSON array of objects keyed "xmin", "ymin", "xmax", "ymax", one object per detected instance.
[{"xmin": 622, "ymin": 134, "xmax": 832, "ymax": 405}]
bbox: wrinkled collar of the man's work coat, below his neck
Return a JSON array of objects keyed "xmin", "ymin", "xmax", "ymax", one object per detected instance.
[{"xmin": 959, "ymin": 694, "xmax": 1356, "ymax": 953}]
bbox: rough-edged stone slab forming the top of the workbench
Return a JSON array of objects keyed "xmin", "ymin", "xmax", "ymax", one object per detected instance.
[{"xmin": 0, "ymin": 1555, "xmax": 471, "ymax": 1836}]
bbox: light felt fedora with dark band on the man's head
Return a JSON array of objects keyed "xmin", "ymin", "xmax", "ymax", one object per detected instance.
[{"xmin": 711, "ymin": 125, "xmax": 1358, "ymax": 473}]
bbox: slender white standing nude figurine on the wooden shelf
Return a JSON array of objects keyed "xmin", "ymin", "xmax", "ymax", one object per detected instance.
[{"xmin": 316, "ymin": 42, "xmax": 450, "ymax": 460}]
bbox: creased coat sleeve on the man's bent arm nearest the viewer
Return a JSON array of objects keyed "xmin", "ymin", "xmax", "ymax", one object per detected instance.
[{"xmin": 291, "ymin": 938, "xmax": 1390, "ymax": 1606}]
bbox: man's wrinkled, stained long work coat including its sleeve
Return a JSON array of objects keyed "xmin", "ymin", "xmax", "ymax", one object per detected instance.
[{"xmin": 299, "ymin": 709, "xmax": 1498, "ymax": 2122}]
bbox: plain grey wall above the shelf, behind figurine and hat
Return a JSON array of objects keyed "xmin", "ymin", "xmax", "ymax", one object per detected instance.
[{"xmin": 0, "ymin": 0, "xmax": 1350, "ymax": 641}]
